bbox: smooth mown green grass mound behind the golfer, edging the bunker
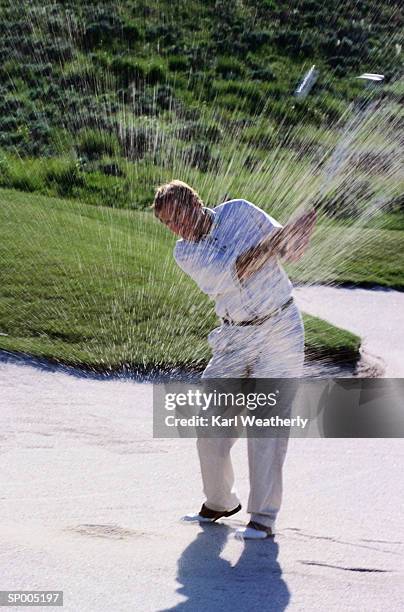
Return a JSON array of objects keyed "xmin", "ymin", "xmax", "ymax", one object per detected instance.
[{"xmin": 0, "ymin": 190, "xmax": 360, "ymax": 369}]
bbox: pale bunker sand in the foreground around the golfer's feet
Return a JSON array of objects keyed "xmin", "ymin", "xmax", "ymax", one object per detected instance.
[{"xmin": 0, "ymin": 286, "xmax": 404, "ymax": 612}]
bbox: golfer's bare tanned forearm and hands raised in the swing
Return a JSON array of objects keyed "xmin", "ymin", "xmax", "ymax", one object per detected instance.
[{"xmin": 236, "ymin": 209, "xmax": 317, "ymax": 280}]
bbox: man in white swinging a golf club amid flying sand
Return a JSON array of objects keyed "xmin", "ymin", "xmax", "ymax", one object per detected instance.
[{"xmin": 153, "ymin": 180, "xmax": 316, "ymax": 539}]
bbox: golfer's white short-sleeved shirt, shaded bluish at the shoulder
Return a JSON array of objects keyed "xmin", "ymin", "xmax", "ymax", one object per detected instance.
[{"xmin": 174, "ymin": 200, "xmax": 293, "ymax": 321}]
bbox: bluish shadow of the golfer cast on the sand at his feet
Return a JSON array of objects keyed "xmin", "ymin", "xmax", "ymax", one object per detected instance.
[{"xmin": 161, "ymin": 524, "xmax": 290, "ymax": 612}]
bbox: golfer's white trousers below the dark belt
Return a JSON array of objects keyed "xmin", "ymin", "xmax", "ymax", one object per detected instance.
[{"xmin": 197, "ymin": 303, "xmax": 304, "ymax": 527}]
